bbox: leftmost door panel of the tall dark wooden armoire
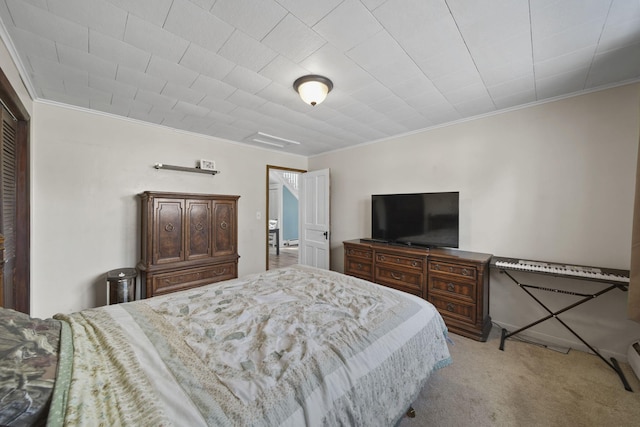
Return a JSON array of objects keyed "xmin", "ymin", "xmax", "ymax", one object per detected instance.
[{"xmin": 153, "ymin": 199, "xmax": 184, "ymax": 264}]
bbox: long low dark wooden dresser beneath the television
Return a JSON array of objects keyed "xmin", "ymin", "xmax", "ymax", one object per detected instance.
[{"xmin": 344, "ymin": 240, "xmax": 491, "ymax": 341}]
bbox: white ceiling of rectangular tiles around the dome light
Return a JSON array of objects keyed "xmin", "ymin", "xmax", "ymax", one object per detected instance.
[{"xmin": 0, "ymin": 0, "xmax": 640, "ymax": 155}]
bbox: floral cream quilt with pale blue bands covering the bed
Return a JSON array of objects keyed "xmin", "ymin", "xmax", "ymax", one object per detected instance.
[{"xmin": 1, "ymin": 266, "xmax": 451, "ymax": 426}]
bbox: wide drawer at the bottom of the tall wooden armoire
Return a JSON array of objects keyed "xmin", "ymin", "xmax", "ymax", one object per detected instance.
[{"xmin": 147, "ymin": 262, "xmax": 238, "ymax": 295}]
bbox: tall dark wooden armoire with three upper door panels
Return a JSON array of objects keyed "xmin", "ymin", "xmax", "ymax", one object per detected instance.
[{"xmin": 137, "ymin": 191, "xmax": 240, "ymax": 298}]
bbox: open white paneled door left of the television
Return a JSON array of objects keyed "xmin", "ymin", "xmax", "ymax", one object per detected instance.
[{"xmin": 299, "ymin": 169, "xmax": 330, "ymax": 270}]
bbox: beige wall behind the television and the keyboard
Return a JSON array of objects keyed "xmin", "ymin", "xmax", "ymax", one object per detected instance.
[{"xmin": 309, "ymin": 84, "xmax": 640, "ymax": 359}]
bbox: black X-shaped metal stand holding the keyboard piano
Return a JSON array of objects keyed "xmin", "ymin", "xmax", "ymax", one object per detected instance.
[{"xmin": 498, "ymin": 267, "xmax": 633, "ymax": 392}]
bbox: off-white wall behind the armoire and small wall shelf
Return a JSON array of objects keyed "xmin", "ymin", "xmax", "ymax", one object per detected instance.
[{"xmin": 31, "ymin": 102, "xmax": 307, "ymax": 317}]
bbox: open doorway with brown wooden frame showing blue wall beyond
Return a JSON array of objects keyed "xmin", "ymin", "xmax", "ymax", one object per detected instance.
[{"xmin": 265, "ymin": 165, "xmax": 306, "ymax": 270}]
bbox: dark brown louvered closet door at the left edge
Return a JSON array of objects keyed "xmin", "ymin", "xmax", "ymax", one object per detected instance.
[{"xmin": 0, "ymin": 107, "xmax": 16, "ymax": 308}]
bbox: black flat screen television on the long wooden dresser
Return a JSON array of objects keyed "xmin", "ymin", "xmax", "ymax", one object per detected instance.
[{"xmin": 371, "ymin": 191, "xmax": 460, "ymax": 248}]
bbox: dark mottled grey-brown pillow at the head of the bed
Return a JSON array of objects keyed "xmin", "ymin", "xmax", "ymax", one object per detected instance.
[{"xmin": 0, "ymin": 308, "xmax": 60, "ymax": 426}]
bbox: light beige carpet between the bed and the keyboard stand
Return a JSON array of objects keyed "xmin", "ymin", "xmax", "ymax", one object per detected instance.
[{"xmin": 399, "ymin": 325, "xmax": 640, "ymax": 427}]
